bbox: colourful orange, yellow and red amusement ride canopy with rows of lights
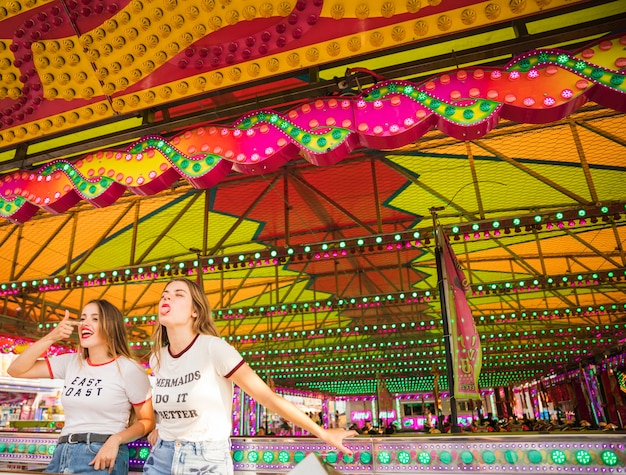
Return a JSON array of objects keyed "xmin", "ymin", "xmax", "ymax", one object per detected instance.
[{"xmin": 0, "ymin": 0, "xmax": 626, "ymax": 395}]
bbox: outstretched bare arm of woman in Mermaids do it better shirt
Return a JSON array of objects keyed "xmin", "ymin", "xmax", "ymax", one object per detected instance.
[{"xmin": 230, "ymin": 364, "xmax": 358, "ymax": 455}]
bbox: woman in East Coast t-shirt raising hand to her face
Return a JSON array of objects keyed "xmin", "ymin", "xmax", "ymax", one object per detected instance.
[{"xmin": 8, "ymin": 300, "xmax": 155, "ymax": 475}]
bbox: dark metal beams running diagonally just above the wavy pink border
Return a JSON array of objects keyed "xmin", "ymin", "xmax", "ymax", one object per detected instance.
[{"xmin": 0, "ymin": 0, "xmax": 624, "ymax": 174}]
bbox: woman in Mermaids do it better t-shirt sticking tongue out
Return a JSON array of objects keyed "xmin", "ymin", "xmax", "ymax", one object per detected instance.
[{"xmin": 143, "ymin": 279, "xmax": 357, "ymax": 475}]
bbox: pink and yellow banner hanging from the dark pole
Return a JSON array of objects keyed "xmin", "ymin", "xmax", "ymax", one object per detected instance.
[{"xmin": 437, "ymin": 228, "xmax": 482, "ymax": 399}]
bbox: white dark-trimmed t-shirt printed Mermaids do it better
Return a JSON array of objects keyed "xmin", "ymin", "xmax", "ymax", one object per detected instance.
[{"xmin": 150, "ymin": 335, "xmax": 244, "ymax": 441}]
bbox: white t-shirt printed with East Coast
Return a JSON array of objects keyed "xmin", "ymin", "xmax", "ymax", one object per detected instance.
[{"xmin": 48, "ymin": 353, "xmax": 151, "ymax": 435}]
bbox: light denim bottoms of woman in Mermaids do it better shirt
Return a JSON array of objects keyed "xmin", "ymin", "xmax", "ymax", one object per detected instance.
[{"xmin": 143, "ymin": 439, "xmax": 234, "ymax": 475}]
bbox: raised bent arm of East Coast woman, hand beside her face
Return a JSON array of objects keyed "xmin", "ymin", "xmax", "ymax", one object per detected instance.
[{"xmin": 7, "ymin": 310, "xmax": 76, "ymax": 378}]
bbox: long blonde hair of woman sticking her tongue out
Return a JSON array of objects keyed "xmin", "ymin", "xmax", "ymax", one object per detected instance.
[{"xmin": 152, "ymin": 277, "xmax": 220, "ymax": 367}]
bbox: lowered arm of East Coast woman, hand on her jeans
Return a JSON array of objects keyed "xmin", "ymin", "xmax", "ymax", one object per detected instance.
[{"xmin": 89, "ymin": 399, "xmax": 155, "ymax": 473}]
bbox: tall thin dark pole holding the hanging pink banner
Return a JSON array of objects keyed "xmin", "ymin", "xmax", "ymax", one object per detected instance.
[{"xmin": 429, "ymin": 207, "xmax": 461, "ymax": 434}]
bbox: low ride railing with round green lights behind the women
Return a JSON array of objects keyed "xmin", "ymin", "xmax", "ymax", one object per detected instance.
[{"xmin": 0, "ymin": 431, "xmax": 626, "ymax": 475}]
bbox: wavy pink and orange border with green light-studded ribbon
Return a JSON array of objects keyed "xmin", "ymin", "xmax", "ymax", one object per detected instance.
[{"xmin": 0, "ymin": 35, "xmax": 626, "ymax": 223}]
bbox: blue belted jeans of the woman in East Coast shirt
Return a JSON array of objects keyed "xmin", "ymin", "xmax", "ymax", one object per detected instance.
[{"xmin": 44, "ymin": 442, "xmax": 128, "ymax": 475}]
